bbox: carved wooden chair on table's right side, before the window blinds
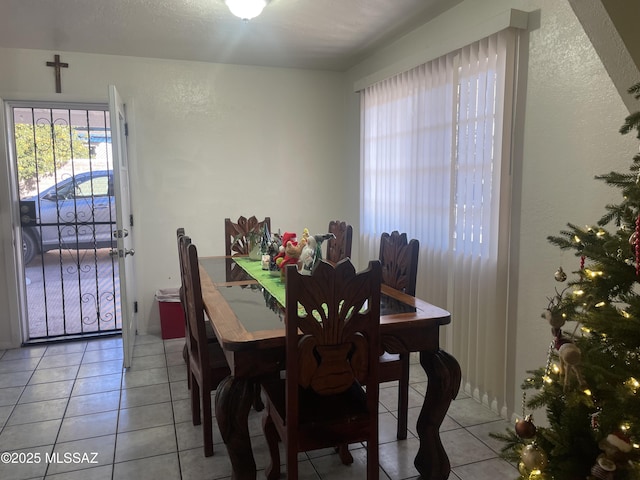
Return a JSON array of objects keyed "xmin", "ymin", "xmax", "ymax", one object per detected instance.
[{"xmin": 379, "ymin": 231, "xmax": 420, "ymax": 440}]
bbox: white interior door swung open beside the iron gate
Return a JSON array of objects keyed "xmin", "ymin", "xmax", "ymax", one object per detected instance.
[{"xmin": 109, "ymin": 85, "xmax": 137, "ymax": 368}]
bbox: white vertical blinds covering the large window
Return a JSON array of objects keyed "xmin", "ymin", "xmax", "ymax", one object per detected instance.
[{"xmin": 360, "ymin": 29, "xmax": 516, "ymax": 414}]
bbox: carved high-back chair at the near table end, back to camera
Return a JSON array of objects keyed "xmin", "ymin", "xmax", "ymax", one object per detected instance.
[{"xmin": 262, "ymin": 259, "xmax": 381, "ymax": 480}]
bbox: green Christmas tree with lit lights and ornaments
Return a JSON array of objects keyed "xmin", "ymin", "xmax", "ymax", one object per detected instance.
[{"xmin": 492, "ymin": 83, "xmax": 640, "ymax": 480}]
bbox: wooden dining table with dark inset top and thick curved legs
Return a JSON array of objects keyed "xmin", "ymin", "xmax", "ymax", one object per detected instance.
[{"xmin": 200, "ymin": 256, "xmax": 461, "ymax": 480}]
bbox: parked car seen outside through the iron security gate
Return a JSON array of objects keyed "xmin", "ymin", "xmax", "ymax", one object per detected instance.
[{"xmin": 21, "ymin": 170, "xmax": 116, "ymax": 264}]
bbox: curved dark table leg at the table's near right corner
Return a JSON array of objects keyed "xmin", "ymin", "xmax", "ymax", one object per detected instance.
[{"xmin": 413, "ymin": 350, "xmax": 462, "ymax": 480}]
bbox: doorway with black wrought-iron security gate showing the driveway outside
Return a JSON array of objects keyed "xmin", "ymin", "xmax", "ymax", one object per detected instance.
[{"xmin": 8, "ymin": 102, "xmax": 122, "ymax": 343}]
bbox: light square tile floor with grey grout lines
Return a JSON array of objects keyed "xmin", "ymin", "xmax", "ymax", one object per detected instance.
[{"xmin": 0, "ymin": 336, "xmax": 518, "ymax": 480}]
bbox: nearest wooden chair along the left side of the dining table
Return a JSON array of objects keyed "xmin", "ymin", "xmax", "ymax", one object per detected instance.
[{"xmin": 180, "ymin": 235, "xmax": 231, "ymax": 457}]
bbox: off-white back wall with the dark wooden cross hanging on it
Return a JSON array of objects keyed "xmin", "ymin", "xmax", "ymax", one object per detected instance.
[{"xmin": 0, "ymin": 49, "xmax": 355, "ymax": 348}]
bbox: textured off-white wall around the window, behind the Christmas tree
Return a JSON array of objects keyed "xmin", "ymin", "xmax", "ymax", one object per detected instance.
[{"xmin": 347, "ymin": 0, "xmax": 638, "ymax": 416}]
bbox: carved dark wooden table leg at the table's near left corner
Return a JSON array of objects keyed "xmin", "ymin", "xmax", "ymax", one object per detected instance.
[{"xmin": 215, "ymin": 377, "xmax": 256, "ymax": 480}]
